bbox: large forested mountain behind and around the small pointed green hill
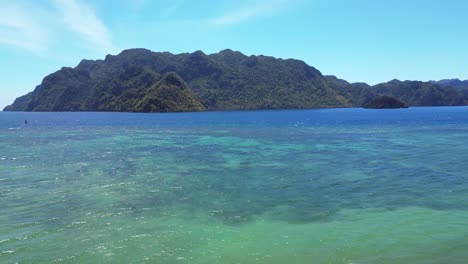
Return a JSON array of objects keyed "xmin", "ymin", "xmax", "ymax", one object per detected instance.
[{"xmin": 2, "ymin": 49, "xmax": 353, "ymax": 111}]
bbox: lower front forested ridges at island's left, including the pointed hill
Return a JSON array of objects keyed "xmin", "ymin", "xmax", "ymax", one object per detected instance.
[{"xmin": 12, "ymin": 65, "xmax": 205, "ymax": 112}]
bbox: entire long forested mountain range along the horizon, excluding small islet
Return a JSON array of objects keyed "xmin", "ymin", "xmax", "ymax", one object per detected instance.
[{"xmin": 4, "ymin": 49, "xmax": 468, "ymax": 112}]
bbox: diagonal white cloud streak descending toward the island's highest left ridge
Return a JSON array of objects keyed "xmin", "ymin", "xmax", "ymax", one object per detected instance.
[{"xmin": 53, "ymin": 0, "xmax": 115, "ymax": 51}]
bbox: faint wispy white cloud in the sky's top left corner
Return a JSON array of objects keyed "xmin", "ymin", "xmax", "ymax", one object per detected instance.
[{"xmin": 0, "ymin": 1, "xmax": 49, "ymax": 53}]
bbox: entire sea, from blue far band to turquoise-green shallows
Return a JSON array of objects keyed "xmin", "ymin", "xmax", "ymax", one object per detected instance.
[{"xmin": 0, "ymin": 107, "xmax": 468, "ymax": 264}]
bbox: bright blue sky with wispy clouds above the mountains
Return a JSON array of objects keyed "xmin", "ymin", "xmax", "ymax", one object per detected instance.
[{"xmin": 0, "ymin": 0, "xmax": 468, "ymax": 109}]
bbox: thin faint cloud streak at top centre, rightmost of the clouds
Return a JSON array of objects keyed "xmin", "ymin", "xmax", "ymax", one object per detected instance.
[{"xmin": 210, "ymin": 0, "xmax": 291, "ymax": 26}]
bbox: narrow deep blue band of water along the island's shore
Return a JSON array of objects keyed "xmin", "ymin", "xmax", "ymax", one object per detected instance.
[{"xmin": 0, "ymin": 107, "xmax": 468, "ymax": 128}]
